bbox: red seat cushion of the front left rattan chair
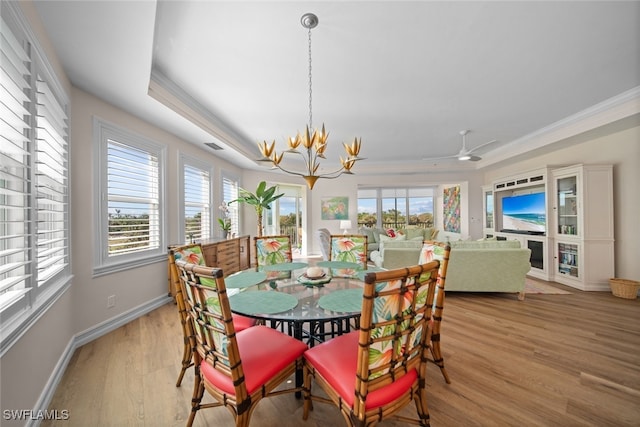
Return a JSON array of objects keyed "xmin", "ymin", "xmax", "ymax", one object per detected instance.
[{"xmin": 200, "ymin": 325, "xmax": 308, "ymax": 395}]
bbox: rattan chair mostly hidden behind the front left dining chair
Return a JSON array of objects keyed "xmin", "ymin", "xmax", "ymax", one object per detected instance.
[{"xmin": 168, "ymin": 243, "xmax": 256, "ymax": 387}]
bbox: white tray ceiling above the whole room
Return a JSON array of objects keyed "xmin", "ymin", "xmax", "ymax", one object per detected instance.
[{"xmin": 35, "ymin": 0, "xmax": 640, "ymax": 174}]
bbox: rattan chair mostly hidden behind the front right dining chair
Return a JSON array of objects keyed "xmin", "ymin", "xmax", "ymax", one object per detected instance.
[{"xmin": 418, "ymin": 240, "xmax": 451, "ymax": 384}]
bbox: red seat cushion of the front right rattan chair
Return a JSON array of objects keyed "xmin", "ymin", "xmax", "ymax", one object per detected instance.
[{"xmin": 304, "ymin": 331, "xmax": 418, "ymax": 410}]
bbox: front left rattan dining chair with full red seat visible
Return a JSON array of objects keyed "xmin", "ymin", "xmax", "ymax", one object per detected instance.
[{"xmin": 176, "ymin": 260, "xmax": 308, "ymax": 427}]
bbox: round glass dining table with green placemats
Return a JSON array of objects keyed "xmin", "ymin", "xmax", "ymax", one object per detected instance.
[{"xmin": 225, "ymin": 261, "xmax": 375, "ymax": 347}]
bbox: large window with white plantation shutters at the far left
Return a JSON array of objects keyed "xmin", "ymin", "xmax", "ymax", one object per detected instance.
[{"xmin": 0, "ymin": 3, "xmax": 71, "ymax": 353}]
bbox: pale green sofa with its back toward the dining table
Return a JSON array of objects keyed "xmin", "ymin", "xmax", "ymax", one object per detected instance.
[{"xmin": 381, "ymin": 240, "xmax": 531, "ymax": 299}]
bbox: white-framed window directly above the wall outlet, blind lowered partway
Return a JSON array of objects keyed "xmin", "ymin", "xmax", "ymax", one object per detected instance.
[{"xmin": 93, "ymin": 118, "xmax": 166, "ymax": 275}]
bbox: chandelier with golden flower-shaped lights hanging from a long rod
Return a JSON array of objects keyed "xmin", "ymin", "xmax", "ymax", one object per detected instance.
[{"xmin": 258, "ymin": 13, "xmax": 364, "ymax": 190}]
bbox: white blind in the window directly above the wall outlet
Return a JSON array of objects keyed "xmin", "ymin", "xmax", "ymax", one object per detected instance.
[{"xmin": 107, "ymin": 139, "xmax": 160, "ymax": 257}]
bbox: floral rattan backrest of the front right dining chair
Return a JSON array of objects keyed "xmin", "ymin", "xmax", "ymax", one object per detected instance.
[{"xmin": 354, "ymin": 260, "xmax": 440, "ymax": 413}]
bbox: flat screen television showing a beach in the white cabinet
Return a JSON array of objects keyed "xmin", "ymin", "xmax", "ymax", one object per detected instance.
[{"xmin": 502, "ymin": 193, "xmax": 547, "ymax": 234}]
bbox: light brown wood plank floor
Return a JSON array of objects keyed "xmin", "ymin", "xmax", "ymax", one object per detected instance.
[{"xmin": 42, "ymin": 285, "xmax": 640, "ymax": 427}]
